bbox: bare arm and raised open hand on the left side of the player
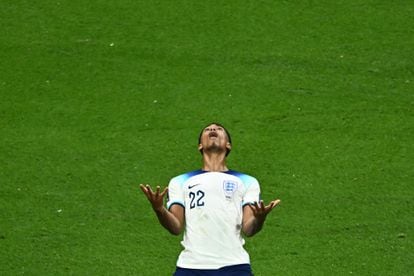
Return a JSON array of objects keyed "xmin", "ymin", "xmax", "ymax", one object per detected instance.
[{"xmin": 140, "ymin": 184, "xmax": 184, "ymax": 235}]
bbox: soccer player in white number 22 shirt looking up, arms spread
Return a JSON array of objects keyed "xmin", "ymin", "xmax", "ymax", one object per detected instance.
[{"xmin": 140, "ymin": 123, "xmax": 280, "ymax": 276}]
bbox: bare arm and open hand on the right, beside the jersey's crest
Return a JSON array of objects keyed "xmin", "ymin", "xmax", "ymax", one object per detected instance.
[{"xmin": 242, "ymin": 199, "xmax": 280, "ymax": 237}]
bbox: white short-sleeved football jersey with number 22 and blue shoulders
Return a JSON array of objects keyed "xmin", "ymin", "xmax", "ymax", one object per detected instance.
[{"xmin": 167, "ymin": 170, "xmax": 260, "ymax": 269}]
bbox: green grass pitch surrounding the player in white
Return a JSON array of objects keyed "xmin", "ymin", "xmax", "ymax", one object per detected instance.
[{"xmin": 0, "ymin": 0, "xmax": 414, "ymax": 276}]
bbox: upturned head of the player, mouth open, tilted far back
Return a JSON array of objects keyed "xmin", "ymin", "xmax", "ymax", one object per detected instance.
[{"xmin": 198, "ymin": 124, "xmax": 231, "ymax": 152}]
